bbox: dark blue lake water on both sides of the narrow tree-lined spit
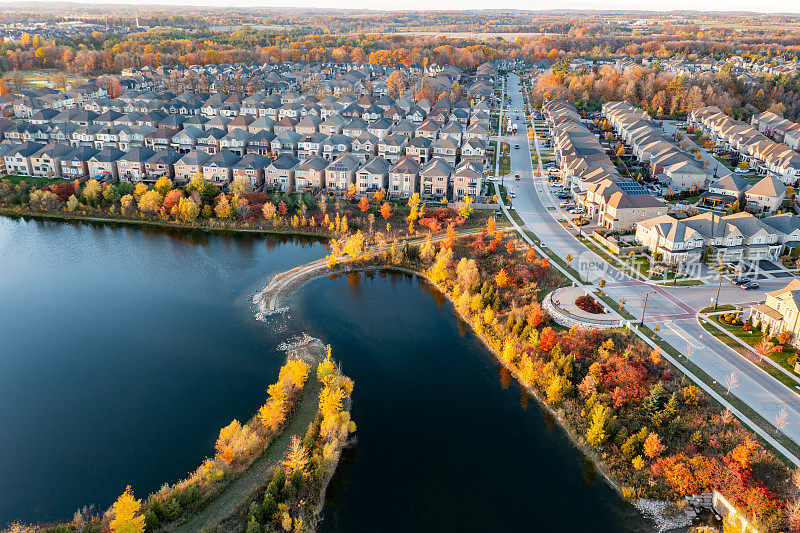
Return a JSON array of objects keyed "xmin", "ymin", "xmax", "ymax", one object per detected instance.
[{"xmin": 0, "ymin": 217, "xmax": 647, "ymax": 532}]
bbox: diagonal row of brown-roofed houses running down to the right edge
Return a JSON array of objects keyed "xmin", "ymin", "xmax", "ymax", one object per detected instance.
[{"xmin": 686, "ymin": 106, "xmax": 800, "ymax": 185}]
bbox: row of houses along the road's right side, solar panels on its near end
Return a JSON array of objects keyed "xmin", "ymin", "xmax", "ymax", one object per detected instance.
[{"xmin": 542, "ymin": 99, "xmax": 667, "ymax": 230}]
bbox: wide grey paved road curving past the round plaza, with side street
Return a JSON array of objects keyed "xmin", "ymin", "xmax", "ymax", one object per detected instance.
[{"xmin": 505, "ymin": 75, "xmax": 800, "ymax": 443}]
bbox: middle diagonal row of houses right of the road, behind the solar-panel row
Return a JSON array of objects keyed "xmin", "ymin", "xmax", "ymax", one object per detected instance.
[{"xmin": 602, "ymin": 102, "xmax": 714, "ymax": 191}]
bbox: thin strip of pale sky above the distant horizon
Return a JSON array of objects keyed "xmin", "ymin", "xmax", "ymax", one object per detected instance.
[{"xmin": 34, "ymin": 0, "xmax": 800, "ymax": 13}]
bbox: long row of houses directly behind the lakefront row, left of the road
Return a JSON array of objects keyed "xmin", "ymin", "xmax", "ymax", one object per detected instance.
[{"xmin": 0, "ymin": 113, "xmax": 489, "ymax": 164}]
